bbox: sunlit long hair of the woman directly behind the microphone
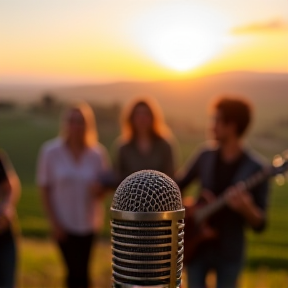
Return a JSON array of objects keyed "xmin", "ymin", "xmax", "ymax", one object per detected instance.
[{"xmin": 120, "ymin": 96, "xmax": 172, "ymax": 142}]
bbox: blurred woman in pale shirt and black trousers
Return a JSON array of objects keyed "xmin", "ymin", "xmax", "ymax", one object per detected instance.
[{"xmin": 37, "ymin": 102, "xmax": 108, "ymax": 288}]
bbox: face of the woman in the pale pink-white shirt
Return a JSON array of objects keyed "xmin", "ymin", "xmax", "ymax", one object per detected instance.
[{"xmin": 66, "ymin": 109, "xmax": 86, "ymax": 142}]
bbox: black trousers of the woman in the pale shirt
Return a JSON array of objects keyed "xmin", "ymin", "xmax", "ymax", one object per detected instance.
[{"xmin": 58, "ymin": 233, "xmax": 95, "ymax": 288}]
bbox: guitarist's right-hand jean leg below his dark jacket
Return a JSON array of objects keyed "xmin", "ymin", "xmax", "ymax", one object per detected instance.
[{"xmin": 216, "ymin": 261, "xmax": 243, "ymax": 288}]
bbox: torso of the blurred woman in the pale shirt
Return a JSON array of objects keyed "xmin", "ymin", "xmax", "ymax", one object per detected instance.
[{"xmin": 49, "ymin": 141, "xmax": 102, "ymax": 233}]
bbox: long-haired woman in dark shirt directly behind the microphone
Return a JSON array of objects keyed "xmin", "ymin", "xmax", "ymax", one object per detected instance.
[{"xmin": 115, "ymin": 97, "xmax": 174, "ymax": 181}]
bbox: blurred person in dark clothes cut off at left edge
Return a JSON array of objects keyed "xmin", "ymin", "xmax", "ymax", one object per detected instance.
[{"xmin": 0, "ymin": 151, "xmax": 20, "ymax": 288}]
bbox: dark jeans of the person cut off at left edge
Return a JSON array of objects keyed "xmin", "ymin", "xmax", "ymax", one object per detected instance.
[{"xmin": 0, "ymin": 229, "xmax": 16, "ymax": 288}]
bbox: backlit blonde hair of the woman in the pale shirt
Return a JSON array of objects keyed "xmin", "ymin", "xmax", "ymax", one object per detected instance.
[{"xmin": 60, "ymin": 101, "xmax": 98, "ymax": 147}]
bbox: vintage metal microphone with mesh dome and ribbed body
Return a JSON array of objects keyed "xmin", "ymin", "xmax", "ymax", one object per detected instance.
[{"xmin": 110, "ymin": 170, "xmax": 185, "ymax": 288}]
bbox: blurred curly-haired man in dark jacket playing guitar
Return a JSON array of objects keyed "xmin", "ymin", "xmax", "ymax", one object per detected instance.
[{"xmin": 176, "ymin": 96, "xmax": 268, "ymax": 288}]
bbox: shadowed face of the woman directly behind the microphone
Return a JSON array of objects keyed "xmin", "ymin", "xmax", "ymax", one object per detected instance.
[{"xmin": 132, "ymin": 104, "xmax": 153, "ymax": 134}]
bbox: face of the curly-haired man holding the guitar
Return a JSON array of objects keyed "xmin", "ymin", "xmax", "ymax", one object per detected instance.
[{"xmin": 211, "ymin": 111, "xmax": 235, "ymax": 143}]
